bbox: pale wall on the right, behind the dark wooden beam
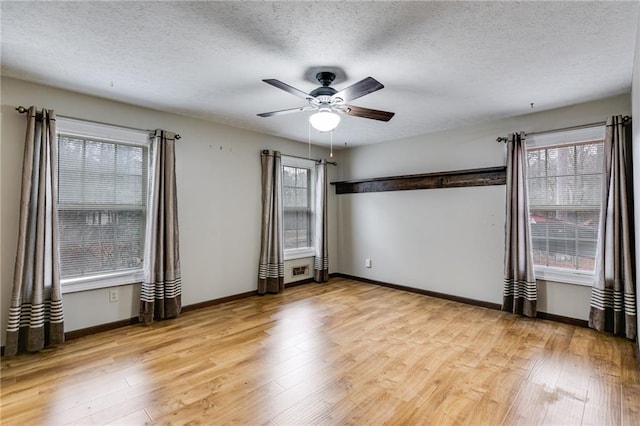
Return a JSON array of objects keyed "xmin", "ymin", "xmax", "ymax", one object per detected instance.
[{"xmin": 337, "ymin": 94, "xmax": 631, "ymax": 319}]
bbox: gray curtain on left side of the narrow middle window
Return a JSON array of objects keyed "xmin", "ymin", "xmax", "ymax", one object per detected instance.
[{"xmin": 258, "ymin": 150, "xmax": 284, "ymax": 294}]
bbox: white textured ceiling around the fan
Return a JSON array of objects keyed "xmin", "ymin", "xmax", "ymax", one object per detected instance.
[{"xmin": 1, "ymin": 1, "xmax": 639, "ymax": 146}]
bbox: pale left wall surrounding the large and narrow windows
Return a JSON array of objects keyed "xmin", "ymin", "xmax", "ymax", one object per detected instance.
[{"xmin": 0, "ymin": 78, "xmax": 338, "ymax": 345}]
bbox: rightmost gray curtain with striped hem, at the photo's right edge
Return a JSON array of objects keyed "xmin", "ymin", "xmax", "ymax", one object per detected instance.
[{"xmin": 589, "ymin": 116, "xmax": 637, "ymax": 339}]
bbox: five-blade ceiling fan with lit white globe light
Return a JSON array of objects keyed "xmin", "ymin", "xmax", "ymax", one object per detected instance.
[{"xmin": 258, "ymin": 71, "xmax": 395, "ymax": 132}]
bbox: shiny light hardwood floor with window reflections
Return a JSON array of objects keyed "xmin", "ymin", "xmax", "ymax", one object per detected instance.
[{"xmin": 1, "ymin": 279, "xmax": 640, "ymax": 425}]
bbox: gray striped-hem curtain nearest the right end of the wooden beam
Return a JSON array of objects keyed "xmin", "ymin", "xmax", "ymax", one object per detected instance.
[{"xmin": 502, "ymin": 133, "xmax": 538, "ymax": 317}]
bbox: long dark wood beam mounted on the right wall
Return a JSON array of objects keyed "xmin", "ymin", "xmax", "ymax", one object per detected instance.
[{"xmin": 331, "ymin": 166, "xmax": 507, "ymax": 194}]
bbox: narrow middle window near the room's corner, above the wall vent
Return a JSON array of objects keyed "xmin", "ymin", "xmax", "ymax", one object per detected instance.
[{"xmin": 282, "ymin": 157, "xmax": 315, "ymax": 259}]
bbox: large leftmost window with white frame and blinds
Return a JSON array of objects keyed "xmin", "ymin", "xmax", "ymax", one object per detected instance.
[{"xmin": 58, "ymin": 119, "xmax": 149, "ymax": 292}]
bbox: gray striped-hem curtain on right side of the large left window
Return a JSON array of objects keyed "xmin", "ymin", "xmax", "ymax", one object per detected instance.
[{"xmin": 139, "ymin": 130, "xmax": 182, "ymax": 323}]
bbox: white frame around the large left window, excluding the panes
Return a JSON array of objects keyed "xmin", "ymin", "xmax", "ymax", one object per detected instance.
[{"xmin": 56, "ymin": 117, "xmax": 152, "ymax": 294}]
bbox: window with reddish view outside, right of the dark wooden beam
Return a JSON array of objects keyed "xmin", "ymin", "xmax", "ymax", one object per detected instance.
[{"xmin": 527, "ymin": 127, "xmax": 604, "ymax": 285}]
